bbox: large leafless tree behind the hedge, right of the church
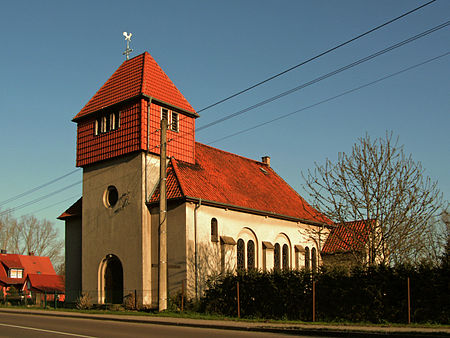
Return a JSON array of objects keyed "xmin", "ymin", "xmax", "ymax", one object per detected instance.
[{"xmin": 303, "ymin": 133, "xmax": 442, "ymax": 264}]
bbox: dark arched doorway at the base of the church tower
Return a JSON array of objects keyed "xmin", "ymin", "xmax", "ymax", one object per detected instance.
[{"xmin": 103, "ymin": 255, "xmax": 123, "ymax": 304}]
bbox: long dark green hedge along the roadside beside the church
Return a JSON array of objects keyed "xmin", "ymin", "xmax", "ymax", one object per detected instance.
[{"xmin": 201, "ymin": 266, "xmax": 450, "ymax": 324}]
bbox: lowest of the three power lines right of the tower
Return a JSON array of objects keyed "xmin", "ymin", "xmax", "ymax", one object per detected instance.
[{"xmin": 207, "ymin": 52, "xmax": 450, "ymax": 145}]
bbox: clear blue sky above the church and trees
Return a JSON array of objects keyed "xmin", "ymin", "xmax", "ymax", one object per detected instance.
[{"xmin": 0, "ymin": 0, "xmax": 450, "ymax": 232}]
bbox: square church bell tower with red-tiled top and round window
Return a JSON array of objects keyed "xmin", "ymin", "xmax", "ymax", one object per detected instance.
[{"xmin": 73, "ymin": 52, "xmax": 198, "ymax": 305}]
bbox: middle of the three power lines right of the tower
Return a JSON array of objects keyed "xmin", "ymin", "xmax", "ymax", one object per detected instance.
[{"xmin": 197, "ymin": 21, "xmax": 450, "ymax": 131}]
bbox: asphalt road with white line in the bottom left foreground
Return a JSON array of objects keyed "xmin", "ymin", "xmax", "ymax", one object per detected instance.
[{"xmin": 0, "ymin": 313, "xmax": 316, "ymax": 338}]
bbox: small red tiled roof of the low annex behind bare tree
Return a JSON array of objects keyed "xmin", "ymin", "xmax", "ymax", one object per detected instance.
[{"xmin": 322, "ymin": 220, "xmax": 374, "ymax": 254}]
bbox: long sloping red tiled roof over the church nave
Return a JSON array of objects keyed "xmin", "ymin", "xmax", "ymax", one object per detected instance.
[{"xmin": 150, "ymin": 143, "xmax": 332, "ymax": 224}]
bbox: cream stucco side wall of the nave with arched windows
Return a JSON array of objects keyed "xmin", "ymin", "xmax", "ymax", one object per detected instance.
[{"xmin": 186, "ymin": 203, "xmax": 329, "ymax": 293}]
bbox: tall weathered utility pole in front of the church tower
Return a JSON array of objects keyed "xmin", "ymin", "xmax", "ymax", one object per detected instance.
[{"xmin": 158, "ymin": 114, "xmax": 167, "ymax": 311}]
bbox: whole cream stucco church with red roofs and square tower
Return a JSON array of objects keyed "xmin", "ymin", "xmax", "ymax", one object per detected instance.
[{"xmin": 58, "ymin": 52, "xmax": 332, "ymax": 307}]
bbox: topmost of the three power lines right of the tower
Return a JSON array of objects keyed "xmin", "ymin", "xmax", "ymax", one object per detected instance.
[{"xmin": 197, "ymin": 0, "xmax": 436, "ymax": 113}]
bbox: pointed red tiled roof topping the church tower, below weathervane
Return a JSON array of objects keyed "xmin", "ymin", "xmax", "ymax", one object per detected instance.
[{"xmin": 73, "ymin": 52, "xmax": 196, "ymax": 121}]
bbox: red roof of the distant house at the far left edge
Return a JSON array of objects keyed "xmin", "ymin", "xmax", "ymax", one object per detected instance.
[{"xmin": 0, "ymin": 254, "xmax": 56, "ymax": 285}]
